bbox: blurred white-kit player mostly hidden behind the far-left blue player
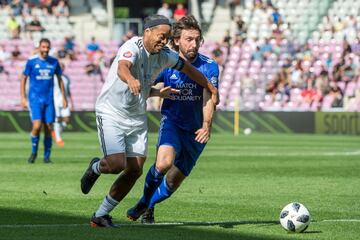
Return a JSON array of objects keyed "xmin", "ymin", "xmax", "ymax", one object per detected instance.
[{"xmin": 52, "ymin": 63, "xmax": 74, "ymax": 146}]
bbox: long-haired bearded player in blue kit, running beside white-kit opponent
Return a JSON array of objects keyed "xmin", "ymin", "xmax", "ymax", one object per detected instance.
[{"xmin": 127, "ymin": 16, "xmax": 219, "ymax": 224}]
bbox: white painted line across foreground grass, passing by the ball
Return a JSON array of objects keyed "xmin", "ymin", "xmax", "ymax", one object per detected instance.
[{"xmin": 0, "ymin": 219, "xmax": 360, "ymax": 229}]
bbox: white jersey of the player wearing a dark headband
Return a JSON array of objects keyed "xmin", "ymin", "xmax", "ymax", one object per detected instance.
[{"xmin": 95, "ymin": 37, "xmax": 179, "ymax": 126}]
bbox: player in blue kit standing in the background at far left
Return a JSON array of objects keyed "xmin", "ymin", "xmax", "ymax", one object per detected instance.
[{"xmin": 20, "ymin": 38, "xmax": 67, "ymax": 163}]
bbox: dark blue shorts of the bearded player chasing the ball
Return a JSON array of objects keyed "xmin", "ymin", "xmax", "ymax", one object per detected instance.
[{"xmin": 157, "ymin": 118, "xmax": 206, "ymax": 176}]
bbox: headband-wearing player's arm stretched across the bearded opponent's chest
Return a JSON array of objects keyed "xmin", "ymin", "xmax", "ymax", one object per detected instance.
[{"xmin": 181, "ymin": 61, "xmax": 219, "ymax": 105}]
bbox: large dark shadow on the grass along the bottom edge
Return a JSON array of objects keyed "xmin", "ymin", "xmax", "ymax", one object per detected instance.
[{"xmin": 0, "ymin": 207, "xmax": 304, "ymax": 240}]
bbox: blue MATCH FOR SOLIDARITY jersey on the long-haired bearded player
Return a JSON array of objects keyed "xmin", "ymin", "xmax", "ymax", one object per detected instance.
[{"xmin": 155, "ymin": 54, "xmax": 219, "ymax": 131}]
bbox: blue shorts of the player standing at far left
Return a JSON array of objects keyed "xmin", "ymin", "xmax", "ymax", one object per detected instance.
[{"xmin": 29, "ymin": 101, "xmax": 55, "ymax": 123}]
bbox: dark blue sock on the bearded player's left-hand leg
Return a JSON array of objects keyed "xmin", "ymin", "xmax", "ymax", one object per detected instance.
[{"xmin": 140, "ymin": 164, "xmax": 164, "ymax": 205}]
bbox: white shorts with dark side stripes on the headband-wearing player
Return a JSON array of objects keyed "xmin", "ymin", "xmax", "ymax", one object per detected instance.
[{"xmin": 96, "ymin": 114, "xmax": 148, "ymax": 157}]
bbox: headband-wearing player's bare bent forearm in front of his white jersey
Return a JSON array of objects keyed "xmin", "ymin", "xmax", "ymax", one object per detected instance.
[{"xmin": 118, "ymin": 60, "xmax": 141, "ymax": 96}]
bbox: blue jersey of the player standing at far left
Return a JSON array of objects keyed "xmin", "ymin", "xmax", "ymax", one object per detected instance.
[{"xmin": 23, "ymin": 56, "xmax": 62, "ymax": 103}]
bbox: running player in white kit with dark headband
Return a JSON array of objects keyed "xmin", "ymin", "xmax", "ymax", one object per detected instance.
[{"xmin": 81, "ymin": 15, "xmax": 218, "ymax": 227}]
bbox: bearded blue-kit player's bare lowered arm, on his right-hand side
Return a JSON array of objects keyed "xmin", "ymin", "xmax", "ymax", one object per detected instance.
[{"xmin": 195, "ymin": 89, "xmax": 215, "ymax": 143}]
